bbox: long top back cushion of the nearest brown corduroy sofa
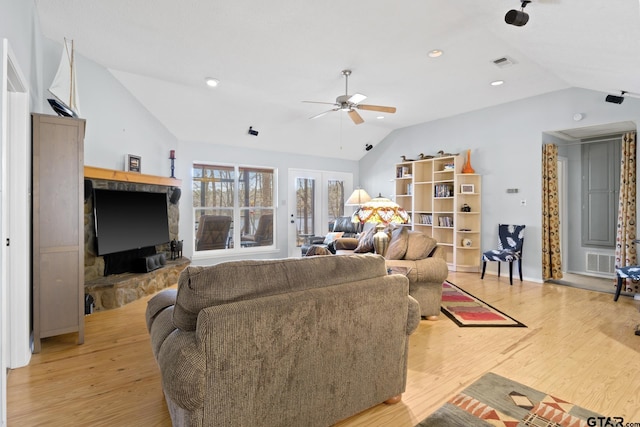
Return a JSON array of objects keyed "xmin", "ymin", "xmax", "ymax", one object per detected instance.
[{"xmin": 173, "ymin": 254, "xmax": 387, "ymax": 331}]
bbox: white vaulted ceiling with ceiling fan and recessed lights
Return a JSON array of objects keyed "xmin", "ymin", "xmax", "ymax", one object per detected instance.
[{"xmin": 36, "ymin": 0, "xmax": 640, "ymax": 160}]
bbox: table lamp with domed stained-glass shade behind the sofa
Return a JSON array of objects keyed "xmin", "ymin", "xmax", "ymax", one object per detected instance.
[{"xmin": 352, "ymin": 194, "xmax": 411, "ymax": 256}]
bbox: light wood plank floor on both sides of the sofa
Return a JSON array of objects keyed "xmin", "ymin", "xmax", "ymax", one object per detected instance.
[{"xmin": 7, "ymin": 273, "xmax": 640, "ymax": 427}]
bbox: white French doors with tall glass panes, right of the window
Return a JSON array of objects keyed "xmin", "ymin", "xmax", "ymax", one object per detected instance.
[{"xmin": 288, "ymin": 169, "xmax": 353, "ymax": 257}]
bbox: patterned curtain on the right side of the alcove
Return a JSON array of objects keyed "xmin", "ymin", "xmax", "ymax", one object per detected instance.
[{"xmin": 616, "ymin": 132, "xmax": 639, "ymax": 293}]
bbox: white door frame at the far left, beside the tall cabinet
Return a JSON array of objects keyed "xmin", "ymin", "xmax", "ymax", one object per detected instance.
[{"xmin": 0, "ymin": 39, "xmax": 31, "ymax": 425}]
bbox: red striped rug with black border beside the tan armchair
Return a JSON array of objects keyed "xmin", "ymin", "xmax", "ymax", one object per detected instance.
[{"xmin": 440, "ymin": 281, "xmax": 526, "ymax": 328}]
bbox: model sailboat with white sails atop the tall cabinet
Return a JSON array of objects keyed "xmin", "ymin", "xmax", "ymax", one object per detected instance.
[{"xmin": 48, "ymin": 38, "xmax": 80, "ymax": 118}]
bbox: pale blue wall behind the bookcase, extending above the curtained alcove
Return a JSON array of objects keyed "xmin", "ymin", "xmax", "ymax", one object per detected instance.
[{"xmin": 360, "ymin": 88, "xmax": 640, "ymax": 281}]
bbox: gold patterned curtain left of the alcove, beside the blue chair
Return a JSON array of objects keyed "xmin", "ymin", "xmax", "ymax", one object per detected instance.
[{"xmin": 542, "ymin": 144, "xmax": 562, "ymax": 280}]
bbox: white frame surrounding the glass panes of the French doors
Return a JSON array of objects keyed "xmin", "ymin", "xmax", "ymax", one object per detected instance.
[{"xmin": 287, "ymin": 169, "xmax": 353, "ymax": 257}]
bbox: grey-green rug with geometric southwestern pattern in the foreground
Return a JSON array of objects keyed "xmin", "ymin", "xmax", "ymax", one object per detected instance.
[{"xmin": 416, "ymin": 372, "xmax": 604, "ymax": 427}]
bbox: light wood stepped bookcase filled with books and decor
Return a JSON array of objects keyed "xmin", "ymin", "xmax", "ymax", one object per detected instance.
[{"xmin": 395, "ymin": 156, "xmax": 482, "ymax": 272}]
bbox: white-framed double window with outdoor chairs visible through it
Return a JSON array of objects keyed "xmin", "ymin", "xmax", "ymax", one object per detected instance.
[{"xmin": 192, "ymin": 163, "xmax": 276, "ymax": 252}]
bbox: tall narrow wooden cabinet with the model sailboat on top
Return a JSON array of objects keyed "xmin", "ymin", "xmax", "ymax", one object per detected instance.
[{"xmin": 32, "ymin": 114, "xmax": 85, "ymax": 353}]
